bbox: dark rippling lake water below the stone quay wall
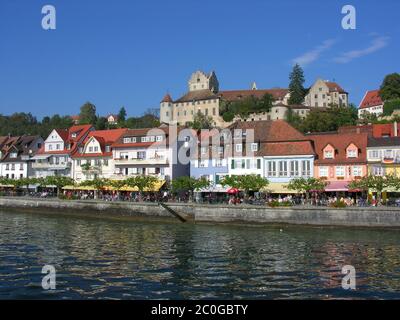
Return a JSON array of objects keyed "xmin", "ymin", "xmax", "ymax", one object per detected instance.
[{"xmin": 0, "ymin": 211, "xmax": 400, "ymax": 299}]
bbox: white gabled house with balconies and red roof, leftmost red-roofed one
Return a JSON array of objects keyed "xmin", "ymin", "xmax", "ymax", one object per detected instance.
[{"xmin": 32, "ymin": 125, "xmax": 94, "ymax": 178}]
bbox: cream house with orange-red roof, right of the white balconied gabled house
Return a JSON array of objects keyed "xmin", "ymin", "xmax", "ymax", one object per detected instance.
[{"xmin": 71, "ymin": 129, "xmax": 127, "ymax": 182}]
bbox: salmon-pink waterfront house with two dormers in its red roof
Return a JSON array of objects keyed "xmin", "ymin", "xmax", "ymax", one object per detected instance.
[{"xmin": 308, "ymin": 133, "xmax": 368, "ymax": 192}]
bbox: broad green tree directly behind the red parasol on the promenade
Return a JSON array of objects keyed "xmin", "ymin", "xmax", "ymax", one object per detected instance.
[{"xmin": 221, "ymin": 174, "xmax": 269, "ymax": 197}]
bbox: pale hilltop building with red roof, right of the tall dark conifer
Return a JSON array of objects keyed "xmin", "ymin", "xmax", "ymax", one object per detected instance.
[{"xmin": 304, "ymin": 79, "xmax": 349, "ymax": 108}]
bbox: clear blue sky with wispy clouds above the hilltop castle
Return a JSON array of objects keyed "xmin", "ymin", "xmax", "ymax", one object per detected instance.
[{"xmin": 0, "ymin": 0, "xmax": 400, "ymax": 118}]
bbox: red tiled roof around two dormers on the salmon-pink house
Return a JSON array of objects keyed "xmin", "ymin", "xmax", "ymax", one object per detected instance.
[{"xmin": 307, "ymin": 133, "xmax": 368, "ymax": 164}]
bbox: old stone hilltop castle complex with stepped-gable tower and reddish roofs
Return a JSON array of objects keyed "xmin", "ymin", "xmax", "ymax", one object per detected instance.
[{"xmin": 160, "ymin": 71, "xmax": 348, "ymax": 128}]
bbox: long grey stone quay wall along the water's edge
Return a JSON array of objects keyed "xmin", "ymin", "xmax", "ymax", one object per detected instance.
[{"xmin": 0, "ymin": 198, "xmax": 400, "ymax": 227}]
